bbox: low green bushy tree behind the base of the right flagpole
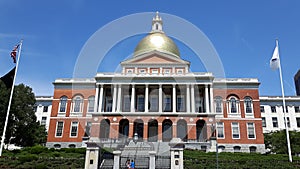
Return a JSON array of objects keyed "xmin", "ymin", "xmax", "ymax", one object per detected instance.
[{"xmin": 264, "ymin": 130, "xmax": 300, "ymax": 155}]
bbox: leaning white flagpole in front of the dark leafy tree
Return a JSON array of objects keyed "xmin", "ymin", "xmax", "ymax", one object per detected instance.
[{"xmin": 0, "ymin": 39, "xmax": 23, "ymax": 157}]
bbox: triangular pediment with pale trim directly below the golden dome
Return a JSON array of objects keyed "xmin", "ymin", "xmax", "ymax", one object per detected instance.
[{"xmin": 122, "ymin": 52, "xmax": 189, "ymax": 64}]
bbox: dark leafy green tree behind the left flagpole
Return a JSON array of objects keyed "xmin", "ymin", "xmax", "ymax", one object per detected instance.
[{"xmin": 0, "ymin": 81, "xmax": 47, "ymax": 147}]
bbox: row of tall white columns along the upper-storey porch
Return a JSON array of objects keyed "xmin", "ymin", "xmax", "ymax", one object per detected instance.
[{"xmin": 94, "ymin": 84, "xmax": 213, "ymax": 113}]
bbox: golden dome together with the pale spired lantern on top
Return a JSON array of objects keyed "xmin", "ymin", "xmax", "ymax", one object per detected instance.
[{"xmin": 133, "ymin": 12, "xmax": 180, "ymax": 58}]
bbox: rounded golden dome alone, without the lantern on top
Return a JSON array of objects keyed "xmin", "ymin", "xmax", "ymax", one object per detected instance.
[{"xmin": 133, "ymin": 32, "xmax": 180, "ymax": 58}]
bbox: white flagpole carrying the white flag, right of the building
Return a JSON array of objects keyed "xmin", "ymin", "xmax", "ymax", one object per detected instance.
[{"xmin": 276, "ymin": 39, "xmax": 293, "ymax": 162}]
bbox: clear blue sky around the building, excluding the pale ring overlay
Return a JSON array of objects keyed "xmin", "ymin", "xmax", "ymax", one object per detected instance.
[{"xmin": 0, "ymin": 0, "xmax": 300, "ymax": 95}]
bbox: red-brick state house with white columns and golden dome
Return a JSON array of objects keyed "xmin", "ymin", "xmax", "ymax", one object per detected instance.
[{"xmin": 47, "ymin": 15, "xmax": 265, "ymax": 152}]
